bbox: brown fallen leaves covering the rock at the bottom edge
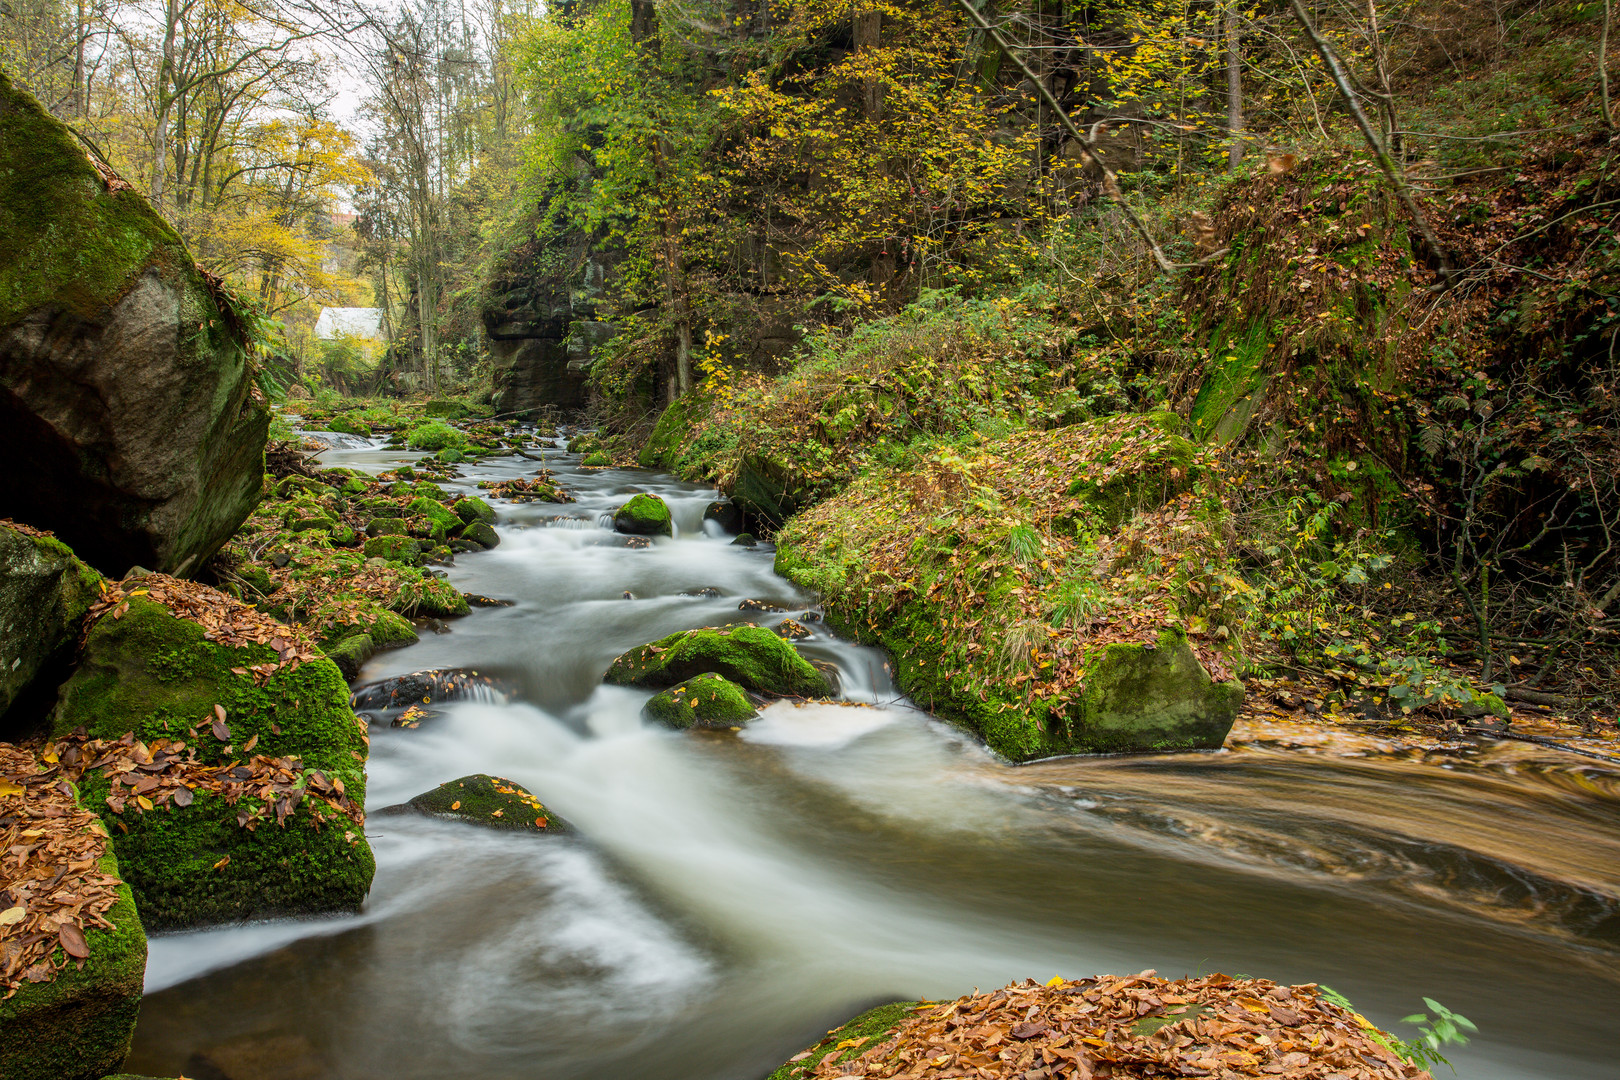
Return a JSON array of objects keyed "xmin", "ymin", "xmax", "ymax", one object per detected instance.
[{"xmin": 795, "ymin": 972, "xmax": 1429, "ymax": 1080}]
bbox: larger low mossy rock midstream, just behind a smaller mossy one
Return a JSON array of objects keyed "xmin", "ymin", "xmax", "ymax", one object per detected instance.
[{"xmin": 604, "ymin": 627, "xmax": 831, "ymax": 698}]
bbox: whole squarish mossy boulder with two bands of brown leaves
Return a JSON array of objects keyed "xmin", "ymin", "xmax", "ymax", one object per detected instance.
[{"xmin": 53, "ymin": 576, "xmax": 374, "ymax": 929}]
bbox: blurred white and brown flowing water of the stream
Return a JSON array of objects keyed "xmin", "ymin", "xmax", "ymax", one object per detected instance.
[{"xmin": 126, "ymin": 440, "xmax": 1620, "ymax": 1080}]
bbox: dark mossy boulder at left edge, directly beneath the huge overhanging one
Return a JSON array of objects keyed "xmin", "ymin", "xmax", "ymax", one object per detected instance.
[{"xmin": 0, "ymin": 526, "xmax": 100, "ymax": 724}]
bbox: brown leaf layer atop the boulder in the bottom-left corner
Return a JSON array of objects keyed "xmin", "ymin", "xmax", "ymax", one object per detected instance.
[{"xmin": 0, "ymin": 743, "xmax": 118, "ymax": 997}]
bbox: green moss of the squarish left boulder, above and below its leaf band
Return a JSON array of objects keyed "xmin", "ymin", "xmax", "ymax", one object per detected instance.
[{"xmin": 53, "ymin": 596, "xmax": 374, "ymax": 929}]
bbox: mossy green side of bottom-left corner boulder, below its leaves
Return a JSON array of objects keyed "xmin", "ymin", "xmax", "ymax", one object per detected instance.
[{"xmin": 0, "ymin": 842, "xmax": 146, "ymax": 1080}]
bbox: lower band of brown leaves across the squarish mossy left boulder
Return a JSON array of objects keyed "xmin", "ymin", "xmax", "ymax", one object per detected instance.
[{"xmin": 53, "ymin": 735, "xmax": 365, "ymax": 832}]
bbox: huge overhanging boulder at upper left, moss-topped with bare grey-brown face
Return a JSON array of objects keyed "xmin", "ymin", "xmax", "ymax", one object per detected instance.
[{"xmin": 0, "ymin": 76, "xmax": 269, "ymax": 575}]
